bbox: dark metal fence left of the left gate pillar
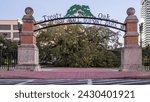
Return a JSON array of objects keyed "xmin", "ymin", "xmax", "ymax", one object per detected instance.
[{"xmin": 0, "ymin": 50, "xmax": 17, "ymax": 71}]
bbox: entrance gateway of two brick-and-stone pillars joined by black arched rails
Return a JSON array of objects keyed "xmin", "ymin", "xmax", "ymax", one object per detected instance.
[{"xmin": 16, "ymin": 7, "xmax": 143, "ymax": 71}]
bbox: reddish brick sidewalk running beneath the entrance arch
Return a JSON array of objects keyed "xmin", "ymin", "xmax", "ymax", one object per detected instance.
[{"xmin": 0, "ymin": 68, "xmax": 150, "ymax": 79}]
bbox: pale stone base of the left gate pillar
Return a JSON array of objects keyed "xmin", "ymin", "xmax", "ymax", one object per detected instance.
[{"xmin": 16, "ymin": 44, "xmax": 40, "ymax": 71}]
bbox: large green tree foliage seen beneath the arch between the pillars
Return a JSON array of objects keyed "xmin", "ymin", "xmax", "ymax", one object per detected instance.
[{"xmin": 37, "ymin": 25, "xmax": 121, "ymax": 67}]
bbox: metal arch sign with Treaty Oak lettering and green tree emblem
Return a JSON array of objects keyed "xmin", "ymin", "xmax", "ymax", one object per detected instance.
[{"xmin": 34, "ymin": 4, "xmax": 125, "ymax": 32}]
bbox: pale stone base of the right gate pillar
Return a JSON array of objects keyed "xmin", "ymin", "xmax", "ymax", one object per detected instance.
[{"xmin": 120, "ymin": 46, "xmax": 144, "ymax": 71}]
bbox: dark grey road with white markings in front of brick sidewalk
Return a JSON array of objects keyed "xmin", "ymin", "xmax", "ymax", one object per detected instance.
[{"xmin": 0, "ymin": 79, "xmax": 150, "ymax": 85}]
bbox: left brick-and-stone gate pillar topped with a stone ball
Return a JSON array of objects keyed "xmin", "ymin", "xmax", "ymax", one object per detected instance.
[{"xmin": 16, "ymin": 7, "xmax": 40, "ymax": 71}]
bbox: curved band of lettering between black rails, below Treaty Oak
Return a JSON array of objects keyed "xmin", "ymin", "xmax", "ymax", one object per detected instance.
[{"xmin": 34, "ymin": 16, "xmax": 126, "ymax": 32}]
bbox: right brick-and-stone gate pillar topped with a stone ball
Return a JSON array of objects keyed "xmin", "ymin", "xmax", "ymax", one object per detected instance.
[{"xmin": 120, "ymin": 7, "xmax": 144, "ymax": 71}]
